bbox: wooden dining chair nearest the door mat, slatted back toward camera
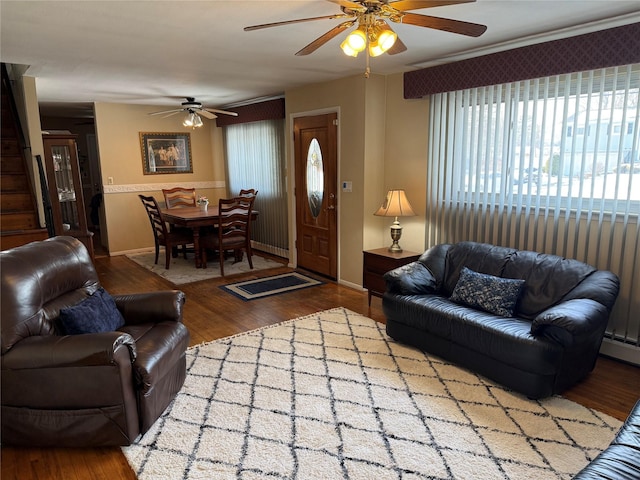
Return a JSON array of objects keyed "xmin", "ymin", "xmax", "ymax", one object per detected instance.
[{"xmin": 200, "ymin": 197, "xmax": 255, "ymax": 277}]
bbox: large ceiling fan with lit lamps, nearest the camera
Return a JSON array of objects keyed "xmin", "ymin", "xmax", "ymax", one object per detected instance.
[{"xmin": 244, "ymin": 0, "xmax": 487, "ymax": 69}]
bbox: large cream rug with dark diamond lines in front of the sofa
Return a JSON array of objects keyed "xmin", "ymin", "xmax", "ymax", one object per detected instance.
[{"xmin": 123, "ymin": 308, "xmax": 621, "ymax": 480}]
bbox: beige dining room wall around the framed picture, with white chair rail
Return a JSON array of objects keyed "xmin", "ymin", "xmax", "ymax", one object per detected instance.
[{"xmin": 94, "ymin": 103, "xmax": 226, "ymax": 255}]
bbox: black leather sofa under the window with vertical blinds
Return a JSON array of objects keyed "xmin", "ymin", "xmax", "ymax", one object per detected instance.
[{"xmin": 382, "ymin": 242, "xmax": 619, "ymax": 398}]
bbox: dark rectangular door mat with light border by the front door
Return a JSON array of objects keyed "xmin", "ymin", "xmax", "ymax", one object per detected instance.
[{"xmin": 220, "ymin": 272, "xmax": 324, "ymax": 301}]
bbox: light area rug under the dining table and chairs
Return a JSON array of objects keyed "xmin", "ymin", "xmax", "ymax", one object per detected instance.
[{"xmin": 127, "ymin": 249, "xmax": 283, "ymax": 285}]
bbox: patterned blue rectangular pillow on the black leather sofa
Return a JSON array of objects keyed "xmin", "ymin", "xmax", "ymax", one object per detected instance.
[{"xmin": 450, "ymin": 267, "xmax": 524, "ymax": 317}]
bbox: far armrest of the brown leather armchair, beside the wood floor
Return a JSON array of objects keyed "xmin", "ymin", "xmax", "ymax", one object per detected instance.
[{"xmin": 113, "ymin": 290, "xmax": 185, "ymax": 325}]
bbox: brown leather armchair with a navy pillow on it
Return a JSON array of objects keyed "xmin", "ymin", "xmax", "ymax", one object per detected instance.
[{"xmin": 0, "ymin": 237, "xmax": 189, "ymax": 447}]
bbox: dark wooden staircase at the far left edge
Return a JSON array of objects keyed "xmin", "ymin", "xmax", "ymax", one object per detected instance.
[{"xmin": 0, "ymin": 65, "xmax": 49, "ymax": 250}]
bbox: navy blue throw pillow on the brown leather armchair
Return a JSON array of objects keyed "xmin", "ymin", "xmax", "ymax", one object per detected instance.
[{"xmin": 58, "ymin": 288, "xmax": 124, "ymax": 335}]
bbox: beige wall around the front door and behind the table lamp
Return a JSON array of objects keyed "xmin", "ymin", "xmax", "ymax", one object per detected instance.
[{"xmin": 286, "ymin": 74, "xmax": 429, "ymax": 286}]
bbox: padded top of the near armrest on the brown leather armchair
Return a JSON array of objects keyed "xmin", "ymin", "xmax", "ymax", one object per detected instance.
[{"xmin": 2, "ymin": 331, "xmax": 136, "ymax": 370}]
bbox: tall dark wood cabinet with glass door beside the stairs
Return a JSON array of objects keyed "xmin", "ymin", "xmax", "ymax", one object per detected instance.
[{"xmin": 42, "ymin": 135, "xmax": 93, "ymax": 258}]
